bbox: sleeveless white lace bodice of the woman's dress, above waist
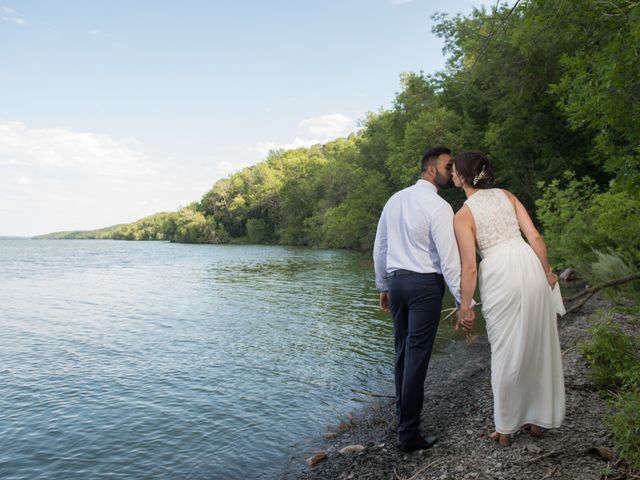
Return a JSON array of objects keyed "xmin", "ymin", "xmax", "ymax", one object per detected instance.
[{"xmin": 464, "ymin": 188, "xmax": 520, "ymax": 251}]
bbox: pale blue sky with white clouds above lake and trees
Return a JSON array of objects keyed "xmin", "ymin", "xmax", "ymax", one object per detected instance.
[{"xmin": 0, "ymin": 0, "xmax": 495, "ymax": 236}]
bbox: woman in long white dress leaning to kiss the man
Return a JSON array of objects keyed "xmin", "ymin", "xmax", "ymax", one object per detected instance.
[{"xmin": 453, "ymin": 152, "xmax": 565, "ymax": 446}]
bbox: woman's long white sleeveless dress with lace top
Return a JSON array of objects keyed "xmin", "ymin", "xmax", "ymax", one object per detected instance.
[{"xmin": 465, "ymin": 189, "xmax": 565, "ymax": 433}]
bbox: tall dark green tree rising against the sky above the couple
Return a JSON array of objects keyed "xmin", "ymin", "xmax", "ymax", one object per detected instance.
[{"xmin": 434, "ymin": 2, "xmax": 592, "ymax": 207}]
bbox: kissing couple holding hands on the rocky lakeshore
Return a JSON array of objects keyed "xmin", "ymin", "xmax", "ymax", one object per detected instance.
[{"xmin": 373, "ymin": 147, "xmax": 565, "ymax": 452}]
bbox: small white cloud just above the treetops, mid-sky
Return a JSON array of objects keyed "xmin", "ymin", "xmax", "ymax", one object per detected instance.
[{"xmin": 255, "ymin": 113, "xmax": 357, "ymax": 155}]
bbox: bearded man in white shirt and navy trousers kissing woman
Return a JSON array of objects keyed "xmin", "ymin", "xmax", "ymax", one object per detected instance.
[{"xmin": 373, "ymin": 147, "xmax": 475, "ymax": 452}]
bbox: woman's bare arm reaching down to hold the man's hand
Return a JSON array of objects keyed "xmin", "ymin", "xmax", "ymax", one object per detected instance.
[{"xmin": 453, "ymin": 205, "xmax": 478, "ymax": 331}]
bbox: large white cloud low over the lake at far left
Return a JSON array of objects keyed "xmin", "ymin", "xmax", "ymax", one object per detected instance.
[{"xmin": 0, "ymin": 121, "xmax": 209, "ymax": 235}]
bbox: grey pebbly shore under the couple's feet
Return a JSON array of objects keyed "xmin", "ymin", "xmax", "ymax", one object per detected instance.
[{"xmin": 280, "ymin": 297, "xmax": 640, "ymax": 480}]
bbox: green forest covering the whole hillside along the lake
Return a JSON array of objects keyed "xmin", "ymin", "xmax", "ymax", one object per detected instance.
[{"xmin": 74, "ymin": 0, "xmax": 640, "ymax": 274}]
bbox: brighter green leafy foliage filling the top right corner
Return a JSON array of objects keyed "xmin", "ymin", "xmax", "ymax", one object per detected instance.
[{"xmin": 542, "ymin": 0, "xmax": 640, "ymax": 192}]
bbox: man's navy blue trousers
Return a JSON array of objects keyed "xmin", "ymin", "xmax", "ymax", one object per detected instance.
[{"xmin": 389, "ymin": 271, "xmax": 444, "ymax": 442}]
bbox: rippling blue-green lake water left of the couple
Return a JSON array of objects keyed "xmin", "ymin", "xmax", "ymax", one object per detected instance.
[{"xmin": 0, "ymin": 240, "xmax": 464, "ymax": 480}]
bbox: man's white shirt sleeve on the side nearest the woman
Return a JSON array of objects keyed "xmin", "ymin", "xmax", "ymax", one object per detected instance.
[{"xmin": 431, "ymin": 203, "xmax": 461, "ymax": 304}]
